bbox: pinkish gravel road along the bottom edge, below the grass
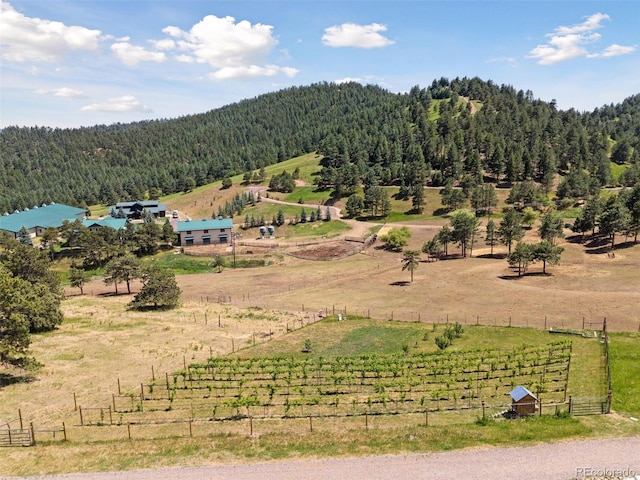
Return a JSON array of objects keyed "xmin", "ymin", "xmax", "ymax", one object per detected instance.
[{"xmin": 10, "ymin": 437, "xmax": 640, "ymax": 480}]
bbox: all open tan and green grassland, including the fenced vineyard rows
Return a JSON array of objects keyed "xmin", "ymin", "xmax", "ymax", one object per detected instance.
[{"xmin": 0, "ymin": 155, "xmax": 640, "ymax": 475}]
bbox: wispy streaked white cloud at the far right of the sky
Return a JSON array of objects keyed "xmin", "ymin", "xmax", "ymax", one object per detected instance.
[{"xmin": 527, "ymin": 13, "xmax": 635, "ymax": 65}]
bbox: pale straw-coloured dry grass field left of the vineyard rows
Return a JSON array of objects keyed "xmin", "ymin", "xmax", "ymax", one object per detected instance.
[{"xmin": 0, "ymin": 295, "xmax": 302, "ymax": 428}]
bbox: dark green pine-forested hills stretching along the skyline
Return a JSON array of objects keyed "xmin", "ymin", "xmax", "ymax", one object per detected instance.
[{"xmin": 0, "ymin": 78, "xmax": 640, "ymax": 213}]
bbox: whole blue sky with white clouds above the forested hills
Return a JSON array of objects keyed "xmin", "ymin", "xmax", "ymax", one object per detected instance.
[{"xmin": 0, "ymin": 0, "xmax": 640, "ymax": 127}]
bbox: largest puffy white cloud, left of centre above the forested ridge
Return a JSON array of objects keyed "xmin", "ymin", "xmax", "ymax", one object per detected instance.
[{"xmin": 159, "ymin": 15, "xmax": 298, "ymax": 80}]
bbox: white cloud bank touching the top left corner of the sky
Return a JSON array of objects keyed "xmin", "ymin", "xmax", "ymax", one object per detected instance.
[{"xmin": 0, "ymin": 2, "xmax": 101, "ymax": 62}]
